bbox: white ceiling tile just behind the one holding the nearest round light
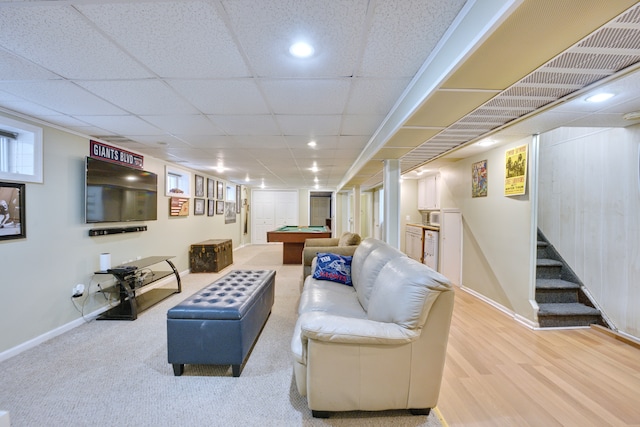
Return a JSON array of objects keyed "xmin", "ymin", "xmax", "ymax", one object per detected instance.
[{"xmin": 260, "ymin": 79, "xmax": 350, "ymax": 114}]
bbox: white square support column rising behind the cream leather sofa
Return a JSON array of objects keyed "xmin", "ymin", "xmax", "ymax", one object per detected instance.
[{"xmin": 382, "ymin": 159, "xmax": 400, "ymax": 249}]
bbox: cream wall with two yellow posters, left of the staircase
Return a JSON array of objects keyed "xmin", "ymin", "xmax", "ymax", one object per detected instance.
[{"xmin": 440, "ymin": 138, "xmax": 535, "ymax": 322}]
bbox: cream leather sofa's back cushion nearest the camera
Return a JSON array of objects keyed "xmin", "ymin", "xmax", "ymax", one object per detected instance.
[{"xmin": 367, "ymin": 257, "xmax": 451, "ymax": 329}]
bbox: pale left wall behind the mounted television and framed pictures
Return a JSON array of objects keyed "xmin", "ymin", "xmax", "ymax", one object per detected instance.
[{"xmin": 0, "ymin": 114, "xmax": 246, "ymax": 359}]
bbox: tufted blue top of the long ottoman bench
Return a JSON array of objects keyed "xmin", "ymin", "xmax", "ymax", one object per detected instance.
[{"xmin": 167, "ymin": 270, "xmax": 276, "ymax": 320}]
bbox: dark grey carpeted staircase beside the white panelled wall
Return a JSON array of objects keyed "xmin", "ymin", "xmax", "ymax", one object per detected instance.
[{"xmin": 536, "ymin": 230, "xmax": 606, "ymax": 328}]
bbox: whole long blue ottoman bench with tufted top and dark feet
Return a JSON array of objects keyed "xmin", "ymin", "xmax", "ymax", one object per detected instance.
[{"xmin": 167, "ymin": 270, "xmax": 276, "ymax": 377}]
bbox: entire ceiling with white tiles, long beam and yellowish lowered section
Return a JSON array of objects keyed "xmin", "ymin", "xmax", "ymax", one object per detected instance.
[{"xmin": 0, "ymin": 0, "xmax": 640, "ymax": 190}]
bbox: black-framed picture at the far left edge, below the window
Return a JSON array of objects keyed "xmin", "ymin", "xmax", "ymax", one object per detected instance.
[{"xmin": 0, "ymin": 182, "xmax": 27, "ymax": 240}]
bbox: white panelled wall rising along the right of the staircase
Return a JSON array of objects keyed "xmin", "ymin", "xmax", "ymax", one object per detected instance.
[{"xmin": 538, "ymin": 126, "xmax": 640, "ymax": 337}]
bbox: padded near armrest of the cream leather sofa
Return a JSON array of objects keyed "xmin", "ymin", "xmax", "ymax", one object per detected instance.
[{"xmin": 299, "ymin": 311, "xmax": 420, "ymax": 345}]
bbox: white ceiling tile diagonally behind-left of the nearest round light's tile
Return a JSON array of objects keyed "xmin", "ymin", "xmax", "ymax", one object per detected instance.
[{"xmin": 168, "ymin": 79, "xmax": 269, "ymax": 114}]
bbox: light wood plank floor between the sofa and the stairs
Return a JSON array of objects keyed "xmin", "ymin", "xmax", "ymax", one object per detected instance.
[{"xmin": 438, "ymin": 289, "xmax": 640, "ymax": 427}]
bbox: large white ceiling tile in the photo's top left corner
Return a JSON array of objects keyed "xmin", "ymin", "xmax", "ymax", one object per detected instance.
[{"xmin": 0, "ymin": 3, "xmax": 150, "ymax": 79}]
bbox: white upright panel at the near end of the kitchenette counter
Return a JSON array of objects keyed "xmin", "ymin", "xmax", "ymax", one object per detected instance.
[{"xmin": 439, "ymin": 209, "xmax": 462, "ymax": 286}]
